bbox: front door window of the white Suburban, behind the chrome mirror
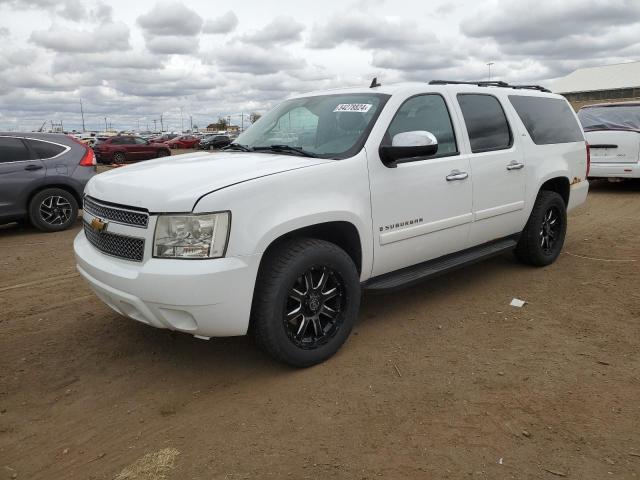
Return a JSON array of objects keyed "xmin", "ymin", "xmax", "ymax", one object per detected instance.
[{"xmin": 384, "ymin": 95, "xmax": 458, "ymax": 156}]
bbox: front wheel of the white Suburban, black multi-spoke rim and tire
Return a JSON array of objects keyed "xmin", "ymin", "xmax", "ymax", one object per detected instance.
[{"xmin": 251, "ymin": 238, "xmax": 360, "ymax": 367}]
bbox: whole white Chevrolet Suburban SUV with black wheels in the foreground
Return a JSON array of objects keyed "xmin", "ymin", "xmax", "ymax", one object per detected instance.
[{"xmin": 74, "ymin": 81, "xmax": 588, "ymax": 367}]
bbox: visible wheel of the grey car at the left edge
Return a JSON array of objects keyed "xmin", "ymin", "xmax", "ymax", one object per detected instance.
[{"xmin": 29, "ymin": 188, "xmax": 78, "ymax": 232}]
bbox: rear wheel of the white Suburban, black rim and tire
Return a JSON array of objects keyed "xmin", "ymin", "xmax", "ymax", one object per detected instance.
[{"xmin": 515, "ymin": 190, "xmax": 567, "ymax": 267}]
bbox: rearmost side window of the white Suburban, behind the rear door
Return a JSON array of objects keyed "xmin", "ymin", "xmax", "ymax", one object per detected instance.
[{"xmin": 509, "ymin": 95, "xmax": 584, "ymax": 145}]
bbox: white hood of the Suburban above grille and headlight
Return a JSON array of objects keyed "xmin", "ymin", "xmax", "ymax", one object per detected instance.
[{"xmin": 85, "ymin": 152, "xmax": 330, "ymax": 212}]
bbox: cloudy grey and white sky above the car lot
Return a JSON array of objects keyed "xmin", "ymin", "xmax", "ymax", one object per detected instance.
[{"xmin": 0, "ymin": 0, "xmax": 640, "ymax": 130}]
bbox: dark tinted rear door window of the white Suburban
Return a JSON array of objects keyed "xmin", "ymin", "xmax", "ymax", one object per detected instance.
[{"xmin": 458, "ymin": 93, "xmax": 511, "ymax": 153}]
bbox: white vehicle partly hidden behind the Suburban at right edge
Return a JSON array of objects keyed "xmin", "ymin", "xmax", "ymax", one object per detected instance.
[{"xmin": 578, "ymin": 102, "xmax": 640, "ymax": 178}]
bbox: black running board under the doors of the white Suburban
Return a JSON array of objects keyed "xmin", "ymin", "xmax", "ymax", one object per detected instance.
[{"xmin": 362, "ymin": 237, "xmax": 518, "ymax": 292}]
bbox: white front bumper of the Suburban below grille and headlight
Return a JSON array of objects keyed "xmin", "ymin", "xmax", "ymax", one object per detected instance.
[{"xmin": 73, "ymin": 232, "xmax": 261, "ymax": 337}]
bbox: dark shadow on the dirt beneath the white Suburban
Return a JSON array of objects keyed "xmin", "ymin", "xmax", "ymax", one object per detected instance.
[{"xmin": 60, "ymin": 251, "xmax": 530, "ymax": 381}]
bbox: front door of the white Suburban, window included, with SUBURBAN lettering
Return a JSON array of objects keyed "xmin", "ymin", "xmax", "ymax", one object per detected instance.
[{"xmin": 367, "ymin": 94, "xmax": 473, "ymax": 276}]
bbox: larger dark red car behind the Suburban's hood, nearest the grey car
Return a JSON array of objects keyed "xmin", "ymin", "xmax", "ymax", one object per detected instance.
[{"xmin": 93, "ymin": 135, "xmax": 171, "ymax": 163}]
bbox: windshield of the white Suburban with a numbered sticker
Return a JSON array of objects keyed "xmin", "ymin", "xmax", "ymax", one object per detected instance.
[{"xmin": 235, "ymin": 93, "xmax": 389, "ymax": 159}]
